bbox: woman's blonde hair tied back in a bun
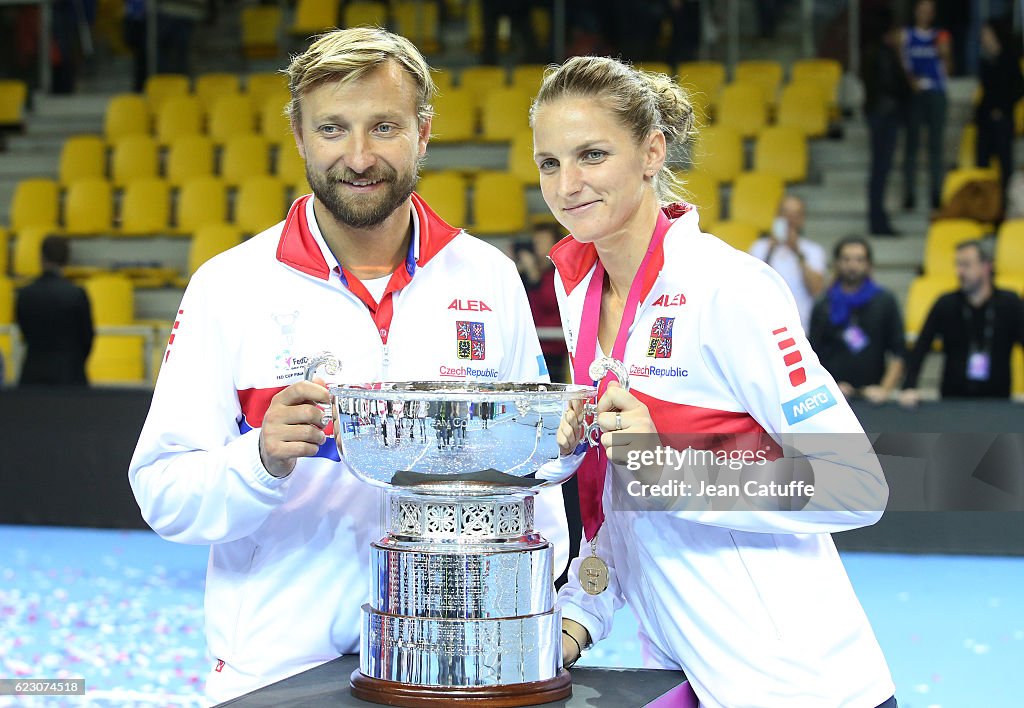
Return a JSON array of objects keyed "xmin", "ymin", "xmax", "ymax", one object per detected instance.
[{"xmin": 529, "ymin": 56, "xmax": 696, "ymax": 204}]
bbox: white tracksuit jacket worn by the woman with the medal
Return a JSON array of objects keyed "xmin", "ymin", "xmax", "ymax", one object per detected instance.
[{"xmin": 552, "ymin": 205, "xmax": 894, "ymax": 708}]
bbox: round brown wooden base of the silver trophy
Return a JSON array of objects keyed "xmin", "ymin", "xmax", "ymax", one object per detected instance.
[{"xmin": 349, "ymin": 669, "xmax": 572, "ymax": 708}]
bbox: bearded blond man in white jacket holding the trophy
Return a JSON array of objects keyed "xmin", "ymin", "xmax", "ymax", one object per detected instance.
[{"xmin": 129, "ymin": 28, "xmax": 566, "ymax": 701}]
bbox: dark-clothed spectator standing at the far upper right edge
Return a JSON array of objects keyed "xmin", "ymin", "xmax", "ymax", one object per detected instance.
[{"xmin": 974, "ymin": 19, "xmax": 1024, "ymax": 203}]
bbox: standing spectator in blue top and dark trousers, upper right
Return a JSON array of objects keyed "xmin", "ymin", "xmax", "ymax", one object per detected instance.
[{"xmin": 903, "ymin": 0, "xmax": 951, "ymax": 211}]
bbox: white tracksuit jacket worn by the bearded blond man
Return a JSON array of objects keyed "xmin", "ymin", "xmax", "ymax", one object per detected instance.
[{"xmin": 129, "ymin": 195, "xmax": 568, "ymax": 701}]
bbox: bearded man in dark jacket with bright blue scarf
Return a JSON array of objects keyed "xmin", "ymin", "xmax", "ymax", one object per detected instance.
[{"xmin": 808, "ymin": 236, "xmax": 906, "ymax": 404}]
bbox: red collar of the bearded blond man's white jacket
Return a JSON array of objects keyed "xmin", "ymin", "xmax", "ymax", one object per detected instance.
[{"xmin": 278, "ymin": 193, "xmax": 462, "ymax": 281}]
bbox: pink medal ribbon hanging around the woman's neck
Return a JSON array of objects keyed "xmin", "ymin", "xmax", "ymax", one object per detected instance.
[{"xmin": 572, "ymin": 210, "xmax": 672, "ymax": 541}]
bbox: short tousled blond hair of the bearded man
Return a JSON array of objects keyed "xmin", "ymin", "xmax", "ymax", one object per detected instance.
[{"xmin": 284, "ymin": 27, "xmax": 437, "ymax": 125}]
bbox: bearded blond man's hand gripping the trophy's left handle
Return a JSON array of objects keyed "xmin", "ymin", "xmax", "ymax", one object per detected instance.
[{"xmin": 259, "ymin": 379, "xmax": 331, "ymax": 477}]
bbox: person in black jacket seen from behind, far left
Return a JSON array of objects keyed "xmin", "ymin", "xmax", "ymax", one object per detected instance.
[{"xmin": 16, "ymin": 236, "xmax": 93, "ymax": 386}]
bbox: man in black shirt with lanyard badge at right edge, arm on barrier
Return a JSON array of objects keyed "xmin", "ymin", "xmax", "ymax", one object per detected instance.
[{"xmin": 899, "ymin": 241, "xmax": 1024, "ymax": 407}]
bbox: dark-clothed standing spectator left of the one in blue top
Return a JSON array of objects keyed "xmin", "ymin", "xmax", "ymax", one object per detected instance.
[{"xmin": 863, "ymin": 14, "xmax": 910, "ymax": 236}]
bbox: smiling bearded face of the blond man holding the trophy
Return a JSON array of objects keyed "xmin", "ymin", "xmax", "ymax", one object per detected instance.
[{"xmin": 293, "ymin": 61, "xmax": 430, "ymax": 228}]
